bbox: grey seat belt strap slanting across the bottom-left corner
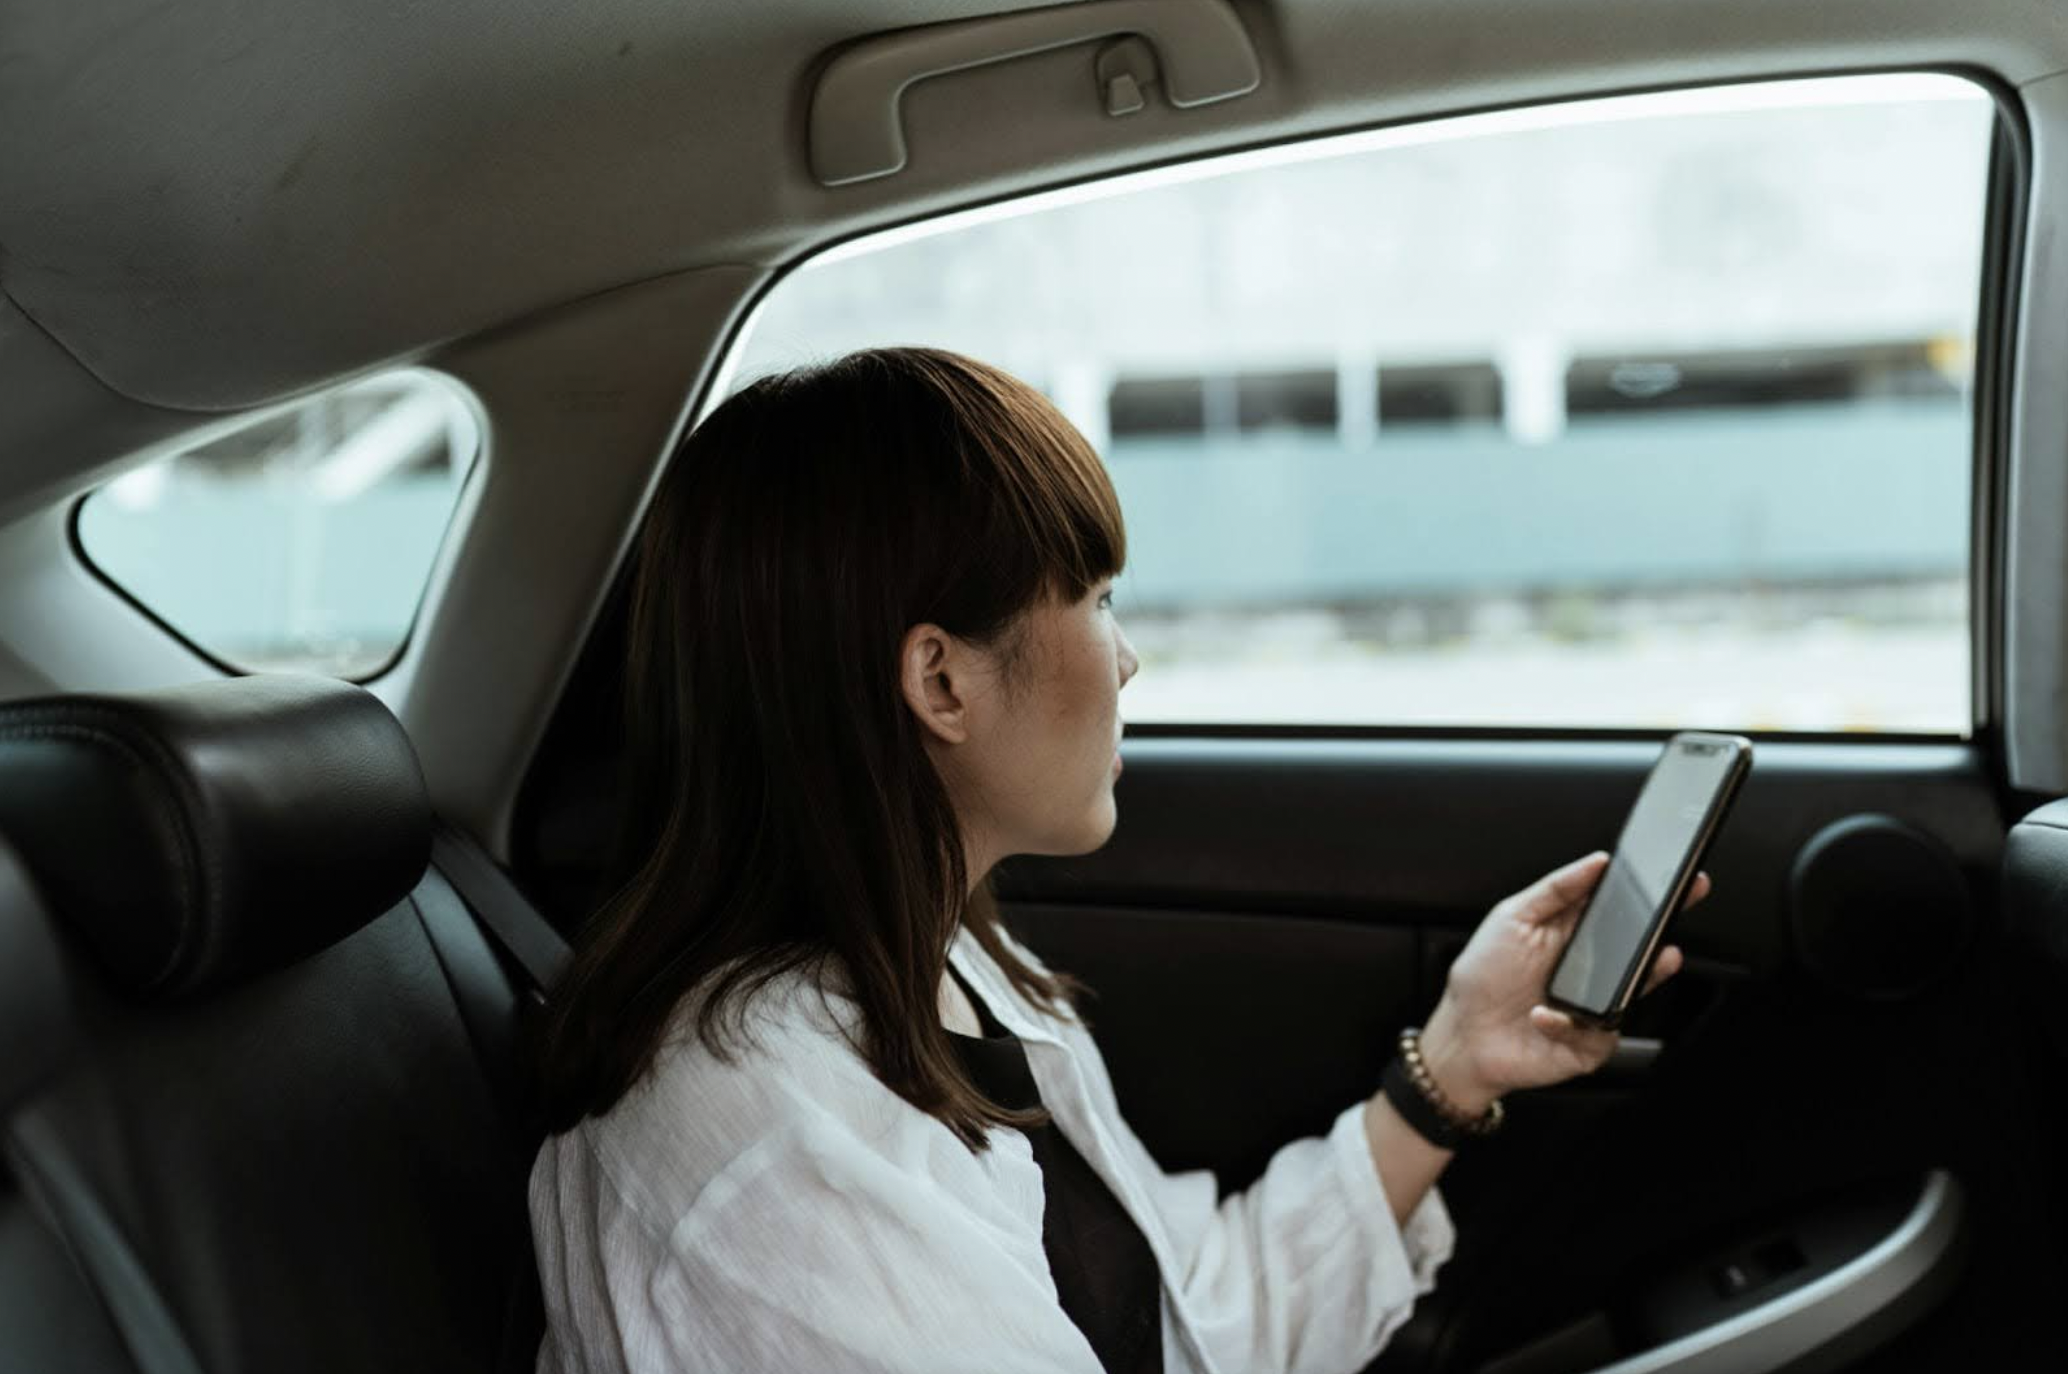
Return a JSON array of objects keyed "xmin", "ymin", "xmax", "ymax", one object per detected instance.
[{"xmin": 8, "ymin": 1111, "xmax": 201, "ymax": 1374}]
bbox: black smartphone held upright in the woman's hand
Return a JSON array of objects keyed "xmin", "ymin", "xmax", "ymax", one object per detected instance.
[{"xmin": 1545, "ymin": 730, "xmax": 1752, "ymax": 1031}]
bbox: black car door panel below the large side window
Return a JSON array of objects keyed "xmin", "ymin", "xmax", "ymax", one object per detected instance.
[{"xmin": 999, "ymin": 735, "xmax": 2045, "ymax": 1368}]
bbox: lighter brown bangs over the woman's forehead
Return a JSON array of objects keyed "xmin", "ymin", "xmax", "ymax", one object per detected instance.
[{"xmin": 914, "ymin": 350, "xmax": 1127, "ymax": 600}]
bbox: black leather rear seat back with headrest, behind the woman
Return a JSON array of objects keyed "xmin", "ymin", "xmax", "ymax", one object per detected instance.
[{"xmin": 0, "ymin": 677, "xmax": 538, "ymax": 1374}]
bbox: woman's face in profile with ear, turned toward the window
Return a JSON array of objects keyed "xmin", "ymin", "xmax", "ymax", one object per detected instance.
[{"xmin": 906, "ymin": 577, "xmax": 1139, "ymax": 882}]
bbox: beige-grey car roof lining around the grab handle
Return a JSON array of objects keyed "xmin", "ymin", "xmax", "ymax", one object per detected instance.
[{"xmin": 0, "ymin": 0, "xmax": 2068, "ymax": 430}]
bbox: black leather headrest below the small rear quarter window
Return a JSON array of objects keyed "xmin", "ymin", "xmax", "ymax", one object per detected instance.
[{"xmin": 0, "ymin": 675, "xmax": 432, "ymax": 999}]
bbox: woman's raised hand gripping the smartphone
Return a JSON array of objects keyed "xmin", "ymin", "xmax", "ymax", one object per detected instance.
[{"xmin": 1421, "ymin": 853, "xmax": 1710, "ymax": 1115}]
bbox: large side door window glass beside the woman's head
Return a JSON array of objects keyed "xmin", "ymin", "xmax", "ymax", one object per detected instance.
[{"xmin": 734, "ymin": 74, "xmax": 1996, "ymax": 733}]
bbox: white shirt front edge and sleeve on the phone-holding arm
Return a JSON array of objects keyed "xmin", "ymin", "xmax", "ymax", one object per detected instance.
[{"xmin": 1050, "ymin": 1009, "xmax": 1456, "ymax": 1374}]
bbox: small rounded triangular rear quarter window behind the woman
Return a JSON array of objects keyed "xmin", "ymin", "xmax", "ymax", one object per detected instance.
[{"xmin": 79, "ymin": 370, "xmax": 480, "ymax": 679}]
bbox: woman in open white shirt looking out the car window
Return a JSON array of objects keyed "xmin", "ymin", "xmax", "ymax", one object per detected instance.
[{"xmin": 531, "ymin": 350, "xmax": 1679, "ymax": 1374}]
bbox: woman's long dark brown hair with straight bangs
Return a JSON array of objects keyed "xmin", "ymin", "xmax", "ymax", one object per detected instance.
[{"xmin": 525, "ymin": 348, "xmax": 1127, "ymax": 1151}]
